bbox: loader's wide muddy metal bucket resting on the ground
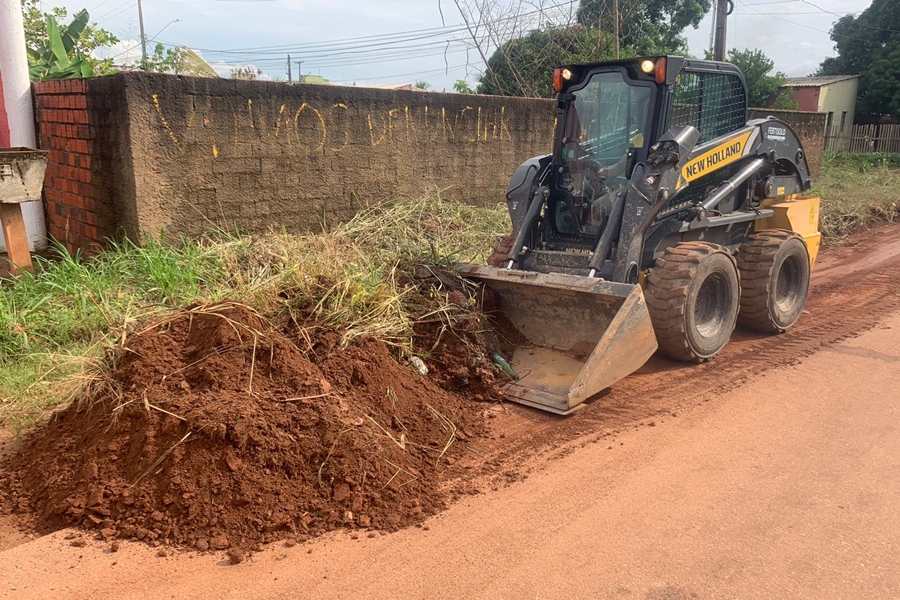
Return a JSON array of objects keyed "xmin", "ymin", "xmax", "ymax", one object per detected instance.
[{"xmin": 460, "ymin": 265, "xmax": 657, "ymax": 415}]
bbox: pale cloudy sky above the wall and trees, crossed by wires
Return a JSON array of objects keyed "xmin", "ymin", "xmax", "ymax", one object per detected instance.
[{"xmin": 44, "ymin": 0, "xmax": 870, "ymax": 91}]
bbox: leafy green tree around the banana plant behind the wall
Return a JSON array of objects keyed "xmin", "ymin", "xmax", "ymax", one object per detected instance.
[{"xmin": 22, "ymin": 0, "xmax": 119, "ymax": 75}]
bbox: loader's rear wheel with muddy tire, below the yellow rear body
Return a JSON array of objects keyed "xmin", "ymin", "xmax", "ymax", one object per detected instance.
[{"xmin": 737, "ymin": 229, "xmax": 809, "ymax": 333}]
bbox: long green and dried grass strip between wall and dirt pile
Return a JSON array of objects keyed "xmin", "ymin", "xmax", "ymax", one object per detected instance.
[{"xmin": 0, "ymin": 195, "xmax": 509, "ymax": 432}]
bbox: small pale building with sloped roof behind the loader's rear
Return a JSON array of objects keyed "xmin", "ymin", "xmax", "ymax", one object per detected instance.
[{"xmin": 779, "ymin": 75, "xmax": 859, "ymax": 150}]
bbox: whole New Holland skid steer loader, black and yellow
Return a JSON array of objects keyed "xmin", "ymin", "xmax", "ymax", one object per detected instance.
[{"xmin": 461, "ymin": 56, "xmax": 820, "ymax": 414}]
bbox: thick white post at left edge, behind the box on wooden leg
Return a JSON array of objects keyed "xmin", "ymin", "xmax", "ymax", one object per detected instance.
[{"xmin": 0, "ymin": 0, "xmax": 47, "ymax": 252}]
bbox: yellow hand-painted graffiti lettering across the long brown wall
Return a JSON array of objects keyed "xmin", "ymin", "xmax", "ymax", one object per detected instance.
[{"xmin": 151, "ymin": 94, "xmax": 528, "ymax": 159}]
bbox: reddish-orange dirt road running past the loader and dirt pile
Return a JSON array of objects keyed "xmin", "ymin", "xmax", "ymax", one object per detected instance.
[{"xmin": 0, "ymin": 226, "xmax": 900, "ymax": 600}]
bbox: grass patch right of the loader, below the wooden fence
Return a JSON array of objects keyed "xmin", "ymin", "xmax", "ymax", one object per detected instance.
[{"xmin": 811, "ymin": 154, "xmax": 900, "ymax": 243}]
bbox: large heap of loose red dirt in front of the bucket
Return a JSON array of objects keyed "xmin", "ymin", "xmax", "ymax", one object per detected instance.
[{"xmin": 0, "ymin": 303, "xmax": 500, "ymax": 550}]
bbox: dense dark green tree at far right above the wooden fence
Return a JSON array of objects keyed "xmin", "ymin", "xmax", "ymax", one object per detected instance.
[{"xmin": 816, "ymin": 0, "xmax": 900, "ymax": 116}]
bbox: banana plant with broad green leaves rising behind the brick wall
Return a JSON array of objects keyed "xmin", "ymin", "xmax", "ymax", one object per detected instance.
[{"xmin": 28, "ymin": 10, "xmax": 94, "ymax": 81}]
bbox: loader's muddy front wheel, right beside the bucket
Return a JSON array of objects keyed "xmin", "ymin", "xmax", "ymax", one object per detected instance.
[{"xmin": 644, "ymin": 242, "xmax": 741, "ymax": 362}]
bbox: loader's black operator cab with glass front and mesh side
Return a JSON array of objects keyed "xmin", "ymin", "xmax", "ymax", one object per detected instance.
[{"xmin": 542, "ymin": 56, "xmax": 747, "ymax": 244}]
